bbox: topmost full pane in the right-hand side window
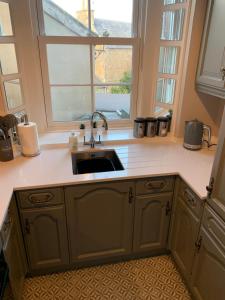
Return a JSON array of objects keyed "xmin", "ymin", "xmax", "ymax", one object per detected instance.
[{"xmin": 161, "ymin": 9, "xmax": 185, "ymax": 41}]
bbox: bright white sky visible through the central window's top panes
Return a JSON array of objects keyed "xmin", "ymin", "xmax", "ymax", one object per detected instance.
[{"xmin": 52, "ymin": 0, "xmax": 133, "ymax": 22}]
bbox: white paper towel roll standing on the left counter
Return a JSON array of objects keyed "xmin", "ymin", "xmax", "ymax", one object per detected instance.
[{"xmin": 17, "ymin": 122, "xmax": 40, "ymax": 156}]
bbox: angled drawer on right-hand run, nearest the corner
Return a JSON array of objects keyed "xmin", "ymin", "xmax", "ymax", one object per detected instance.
[{"xmin": 179, "ymin": 181, "xmax": 204, "ymax": 218}]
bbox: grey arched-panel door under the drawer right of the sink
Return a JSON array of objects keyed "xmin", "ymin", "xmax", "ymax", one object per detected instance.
[{"xmin": 134, "ymin": 193, "xmax": 173, "ymax": 252}]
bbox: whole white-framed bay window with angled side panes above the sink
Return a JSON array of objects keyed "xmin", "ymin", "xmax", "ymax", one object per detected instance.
[{"xmin": 0, "ymin": 0, "xmax": 192, "ymax": 131}]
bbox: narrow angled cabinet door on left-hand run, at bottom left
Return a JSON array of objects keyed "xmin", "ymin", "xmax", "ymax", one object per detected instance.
[{"xmin": 3, "ymin": 222, "xmax": 25, "ymax": 300}]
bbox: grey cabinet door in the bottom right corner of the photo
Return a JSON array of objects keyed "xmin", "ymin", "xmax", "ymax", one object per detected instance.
[{"xmin": 191, "ymin": 228, "xmax": 225, "ymax": 300}]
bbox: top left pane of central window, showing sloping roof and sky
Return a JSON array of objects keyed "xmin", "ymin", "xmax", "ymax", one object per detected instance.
[{"xmin": 42, "ymin": 0, "xmax": 91, "ymax": 36}]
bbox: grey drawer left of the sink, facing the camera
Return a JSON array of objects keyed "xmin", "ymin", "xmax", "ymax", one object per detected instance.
[{"xmin": 18, "ymin": 188, "xmax": 64, "ymax": 208}]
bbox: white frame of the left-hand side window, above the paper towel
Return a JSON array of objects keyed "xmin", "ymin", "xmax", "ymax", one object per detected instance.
[{"xmin": 0, "ymin": 0, "xmax": 25, "ymax": 114}]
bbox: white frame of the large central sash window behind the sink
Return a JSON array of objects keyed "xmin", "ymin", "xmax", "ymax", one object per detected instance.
[{"xmin": 37, "ymin": 0, "xmax": 143, "ymax": 130}]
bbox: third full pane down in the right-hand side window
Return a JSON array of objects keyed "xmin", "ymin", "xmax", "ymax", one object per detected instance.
[{"xmin": 156, "ymin": 78, "xmax": 175, "ymax": 104}]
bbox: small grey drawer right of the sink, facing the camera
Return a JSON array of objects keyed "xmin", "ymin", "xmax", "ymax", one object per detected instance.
[{"xmin": 136, "ymin": 177, "xmax": 174, "ymax": 195}]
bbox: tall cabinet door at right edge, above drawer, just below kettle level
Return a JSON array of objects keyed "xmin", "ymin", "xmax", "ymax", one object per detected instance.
[{"xmin": 207, "ymin": 110, "xmax": 225, "ymax": 220}]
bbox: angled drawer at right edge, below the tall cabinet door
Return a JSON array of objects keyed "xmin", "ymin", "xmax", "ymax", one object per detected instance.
[{"xmin": 202, "ymin": 205, "xmax": 225, "ymax": 251}]
